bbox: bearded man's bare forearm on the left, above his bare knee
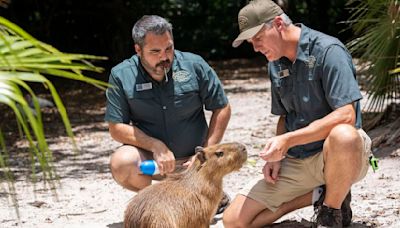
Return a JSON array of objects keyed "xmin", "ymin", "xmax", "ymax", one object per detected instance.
[{"xmin": 109, "ymin": 123, "xmax": 162, "ymax": 152}]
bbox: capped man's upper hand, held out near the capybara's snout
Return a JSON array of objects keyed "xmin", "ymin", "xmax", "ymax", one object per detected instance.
[{"xmin": 259, "ymin": 134, "xmax": 289, "ymax": 162}]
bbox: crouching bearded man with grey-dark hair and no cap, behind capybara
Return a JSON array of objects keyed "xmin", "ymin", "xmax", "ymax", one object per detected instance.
[{"xmin": 105, "ymin": 15, "xmax": 231, "ymax": 212}]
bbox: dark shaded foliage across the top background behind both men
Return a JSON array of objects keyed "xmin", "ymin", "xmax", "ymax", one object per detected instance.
[{"xmin": 0, "ymin": 0, "xmax": 351, "ymax": 62}]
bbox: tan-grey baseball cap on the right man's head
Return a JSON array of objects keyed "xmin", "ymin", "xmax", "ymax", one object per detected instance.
[{"xmin": 232, "ymin": 0, "xmax": 283, "ymax": 47}]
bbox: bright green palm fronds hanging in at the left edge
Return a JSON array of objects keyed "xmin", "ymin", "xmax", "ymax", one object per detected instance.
[{"xmin": 0, "ymin": 17, "xmax": 107, "ymax": 212}]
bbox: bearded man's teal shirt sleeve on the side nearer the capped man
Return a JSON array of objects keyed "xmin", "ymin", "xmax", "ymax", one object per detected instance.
[{"xmin": 199, "ymin": 60, "xmax": 228, "ymax": 110}]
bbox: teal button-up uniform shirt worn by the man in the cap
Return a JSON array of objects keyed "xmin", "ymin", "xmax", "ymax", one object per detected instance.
[{"xmin": 268, "ymin": 24, "xmax": 362, "ymax": 158}]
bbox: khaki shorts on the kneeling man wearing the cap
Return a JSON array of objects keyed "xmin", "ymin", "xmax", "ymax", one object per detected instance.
[{"xmin": 239, "ymin": 129, "xmax": 371, "ymax": 211}]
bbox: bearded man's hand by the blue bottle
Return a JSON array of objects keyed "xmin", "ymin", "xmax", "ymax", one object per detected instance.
[{"xmin": 152, "ymin": 141, "xmax": 175, "ymax": 175}]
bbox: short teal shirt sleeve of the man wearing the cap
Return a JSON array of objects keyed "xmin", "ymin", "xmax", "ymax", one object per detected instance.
[{"xmin": 321, "ymin": 45, "xmax": 362, "ymax": 109}]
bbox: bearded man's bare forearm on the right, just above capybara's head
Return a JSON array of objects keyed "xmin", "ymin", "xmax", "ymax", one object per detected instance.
[{"xmin": 204, "ymin": 104, "xmax": 231, "ymax": 146}]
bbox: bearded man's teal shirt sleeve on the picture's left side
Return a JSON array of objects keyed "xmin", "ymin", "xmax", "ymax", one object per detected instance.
[{"xmin": 104, "ymin": 72, "xmax": 130, "ymax": 123}]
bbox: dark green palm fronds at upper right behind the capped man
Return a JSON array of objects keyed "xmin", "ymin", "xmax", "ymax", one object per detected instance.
[{"xmin": 348, "ymin": 0, "xmax": 400, "ymax": 111}]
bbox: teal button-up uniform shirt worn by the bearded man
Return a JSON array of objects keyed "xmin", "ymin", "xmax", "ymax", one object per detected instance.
[{"xmin": 105, "ymin": 50, "xmax": 228, "ymax": 158}]
